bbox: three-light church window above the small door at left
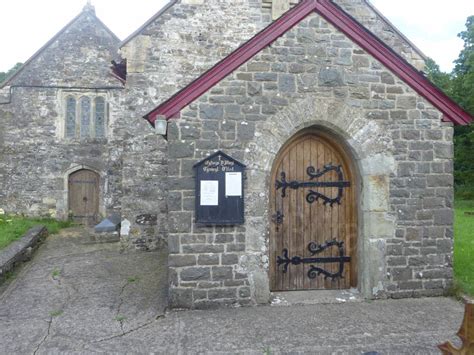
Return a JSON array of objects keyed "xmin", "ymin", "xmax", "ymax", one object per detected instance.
[{"xmin": 64, "ymin": 93, "xmax": 107, "ymax": 140}]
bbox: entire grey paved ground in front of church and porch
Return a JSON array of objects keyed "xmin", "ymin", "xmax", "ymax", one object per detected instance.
[{"xmin": 0, "ymin": 230, "xmax": 463, "ymax": 354}]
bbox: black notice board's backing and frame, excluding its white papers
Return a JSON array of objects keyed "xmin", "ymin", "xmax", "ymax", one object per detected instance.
[{"xmin": 193, "ymin": 150, "xmax": 246, "ymax": 225}]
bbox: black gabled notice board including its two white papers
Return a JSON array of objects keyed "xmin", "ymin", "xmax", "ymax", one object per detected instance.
[{"xmin": 194, "ymin": 151, "xmax": 245, "ymax": 225}]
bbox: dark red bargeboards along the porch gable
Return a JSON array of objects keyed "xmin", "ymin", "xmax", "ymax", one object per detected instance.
[{"xmin": 144, "ymin": 0, "xmax": 472, "ymax": 125}]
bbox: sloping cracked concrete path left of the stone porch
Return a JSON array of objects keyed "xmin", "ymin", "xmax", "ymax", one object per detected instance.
[{"xmin": 0, "ymin": 228, "xmax": 167, "ymax": 354}]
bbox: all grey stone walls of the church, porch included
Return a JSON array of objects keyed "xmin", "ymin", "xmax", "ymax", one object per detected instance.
[{"xmin": 0, "ymin": 0, "xmax": 470, "ymax": 308}]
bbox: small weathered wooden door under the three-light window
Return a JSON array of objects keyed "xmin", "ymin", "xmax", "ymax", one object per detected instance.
[{"xmin": 68, "ymin": 169, "xmax": 99, "ymax": 226}]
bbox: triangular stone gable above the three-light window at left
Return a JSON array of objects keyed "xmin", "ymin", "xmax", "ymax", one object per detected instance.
[{"xmin": 4, "ymin": 5, "xmax": 120, "ymax": 87}]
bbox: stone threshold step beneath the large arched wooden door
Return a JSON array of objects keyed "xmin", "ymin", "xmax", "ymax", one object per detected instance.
[{"xmin": 270, "ymin": 288, "xmax": 364, "ymax": 306}]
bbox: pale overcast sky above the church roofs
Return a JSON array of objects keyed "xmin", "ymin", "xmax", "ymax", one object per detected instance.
[{"xmin": 0, "ymin": 0, "xmax": 474, "ymax": 72}]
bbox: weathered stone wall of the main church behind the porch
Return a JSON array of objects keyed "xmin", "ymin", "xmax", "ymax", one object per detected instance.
[{"xmin": 0, "ymin": 0, "xmax": 434, "ymax": 253}]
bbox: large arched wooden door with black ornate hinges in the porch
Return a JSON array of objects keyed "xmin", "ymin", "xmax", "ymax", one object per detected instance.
[{"xmin": 269, "ymin": 132, "xmax": 357, "ymax": 291}]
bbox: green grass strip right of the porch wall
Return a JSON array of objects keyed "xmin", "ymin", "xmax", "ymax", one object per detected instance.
[{"xmin": 454, "ymin": 199, "xmax": 474, "ymax": 295}]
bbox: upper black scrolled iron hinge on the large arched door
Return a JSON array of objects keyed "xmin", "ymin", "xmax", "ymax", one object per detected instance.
[{"xmin": 275, "ymin": 163, "xmax": 351, "ymax": 206}]
